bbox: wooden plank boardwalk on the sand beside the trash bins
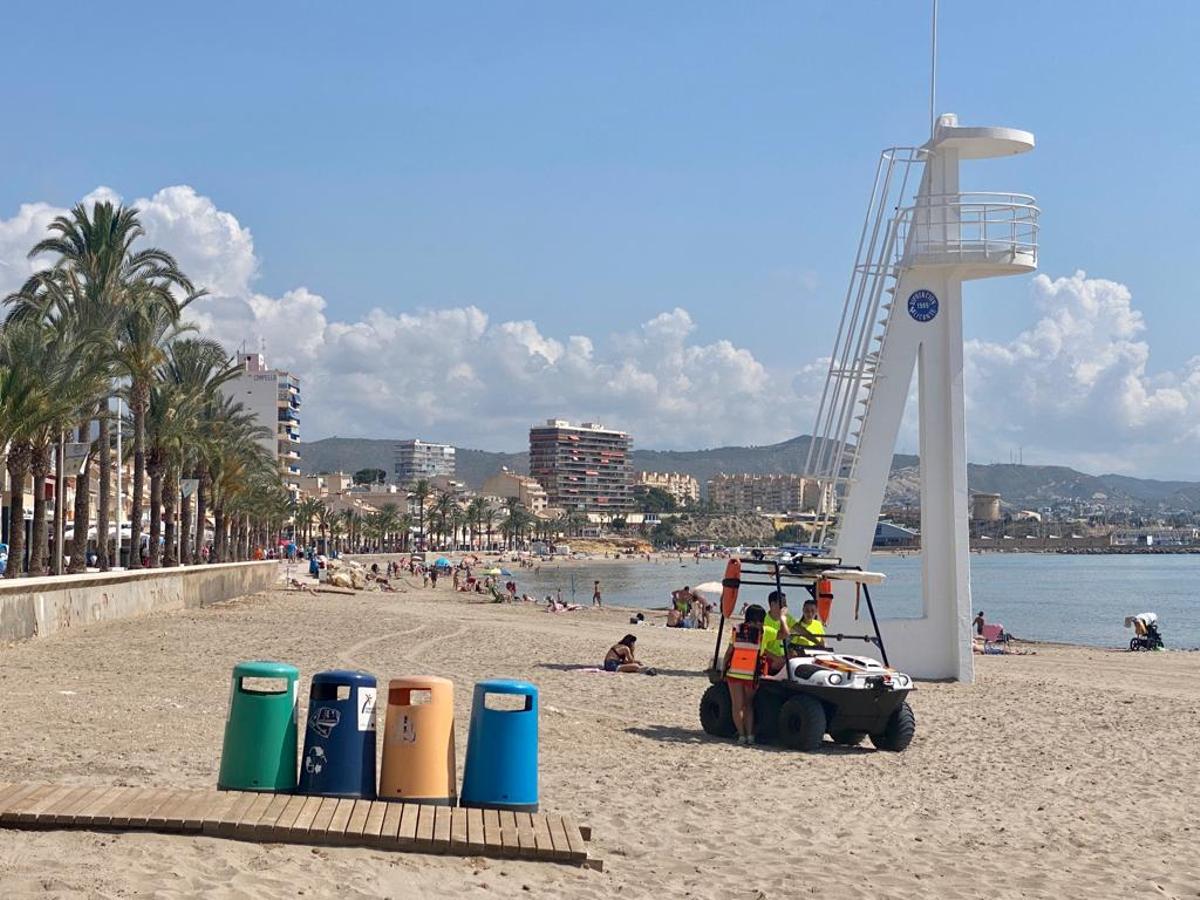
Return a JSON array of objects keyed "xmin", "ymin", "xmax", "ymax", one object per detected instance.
[{"xmin": 0, "ymin": 782, "xmax": 600, "ymax": 868}]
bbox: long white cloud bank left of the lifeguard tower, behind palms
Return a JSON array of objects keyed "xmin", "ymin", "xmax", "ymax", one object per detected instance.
[{"xmin": 0, "ymin": 186, "xmax": 805, "ymax": 448}]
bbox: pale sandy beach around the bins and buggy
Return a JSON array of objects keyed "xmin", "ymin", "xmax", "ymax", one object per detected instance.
[{"xmin": 0, "ymin": 571, "xmax": 1200, "ymax": 900}]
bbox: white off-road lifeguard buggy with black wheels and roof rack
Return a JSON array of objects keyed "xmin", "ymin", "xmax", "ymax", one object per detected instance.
[{"xmin": 700, "ymin": 552, "xmax": 917, "ymax": 752}]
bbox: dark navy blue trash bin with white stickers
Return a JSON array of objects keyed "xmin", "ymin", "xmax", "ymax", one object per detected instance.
[{"xmin": 296, "ymin": 670, "xmax": 376, "ymax": 800}]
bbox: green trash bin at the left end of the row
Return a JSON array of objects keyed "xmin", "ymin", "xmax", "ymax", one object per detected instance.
[{"xmin": 217, "ymin": 660, "xmax": 300, "ymax": 793}]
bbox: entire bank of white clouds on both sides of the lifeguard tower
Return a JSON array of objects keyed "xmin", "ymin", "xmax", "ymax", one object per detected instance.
[{"xmin": 0, "ymin": 186, "xmax": 1200, "ymax": 476}]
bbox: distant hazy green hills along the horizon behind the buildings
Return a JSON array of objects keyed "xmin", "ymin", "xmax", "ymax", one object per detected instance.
[{"xmin": 301, "ymin": 436, "xmax": 1200, "ymax": 511}]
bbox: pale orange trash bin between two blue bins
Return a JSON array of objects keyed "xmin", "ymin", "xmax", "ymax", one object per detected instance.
[{"xmin": 379, "ymin": 676, "xmax": 458, "ymax": 806}]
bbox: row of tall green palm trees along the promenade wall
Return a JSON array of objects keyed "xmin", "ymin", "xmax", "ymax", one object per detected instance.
[{"xmin": 0, "ymin": 203, "xmax": 289, "ymax": 577}]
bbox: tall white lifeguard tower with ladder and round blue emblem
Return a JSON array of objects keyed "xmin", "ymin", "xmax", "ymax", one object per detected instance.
[{"xmin": 806, "ymin": 115, "xmax": 1039, "ymax": 682}]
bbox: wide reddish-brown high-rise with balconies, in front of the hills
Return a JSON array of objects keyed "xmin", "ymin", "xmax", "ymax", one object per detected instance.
[{"xmin": 529, "ymin": 419, "xmax": 634, "ymax": 515}]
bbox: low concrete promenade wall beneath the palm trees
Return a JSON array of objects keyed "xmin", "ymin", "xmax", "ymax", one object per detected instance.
[{"xmin": 0, "ymin": 562, "xmax": 280, "ymax": 641}]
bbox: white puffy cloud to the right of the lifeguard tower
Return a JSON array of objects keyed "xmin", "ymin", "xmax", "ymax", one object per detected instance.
[{"xmin": 966, "ymin": 271, "xmax": 1200, "ymax": 476}]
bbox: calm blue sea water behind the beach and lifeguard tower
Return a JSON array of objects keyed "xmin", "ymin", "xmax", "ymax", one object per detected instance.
[{"xmin": 514, "ymin": 553, "xmax": 1200, "ymax": 649}]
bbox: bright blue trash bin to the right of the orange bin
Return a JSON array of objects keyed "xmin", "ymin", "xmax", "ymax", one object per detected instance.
[{"xmin": 458, "ymin": 678, "xmax": 538, "ymax": 812}]
